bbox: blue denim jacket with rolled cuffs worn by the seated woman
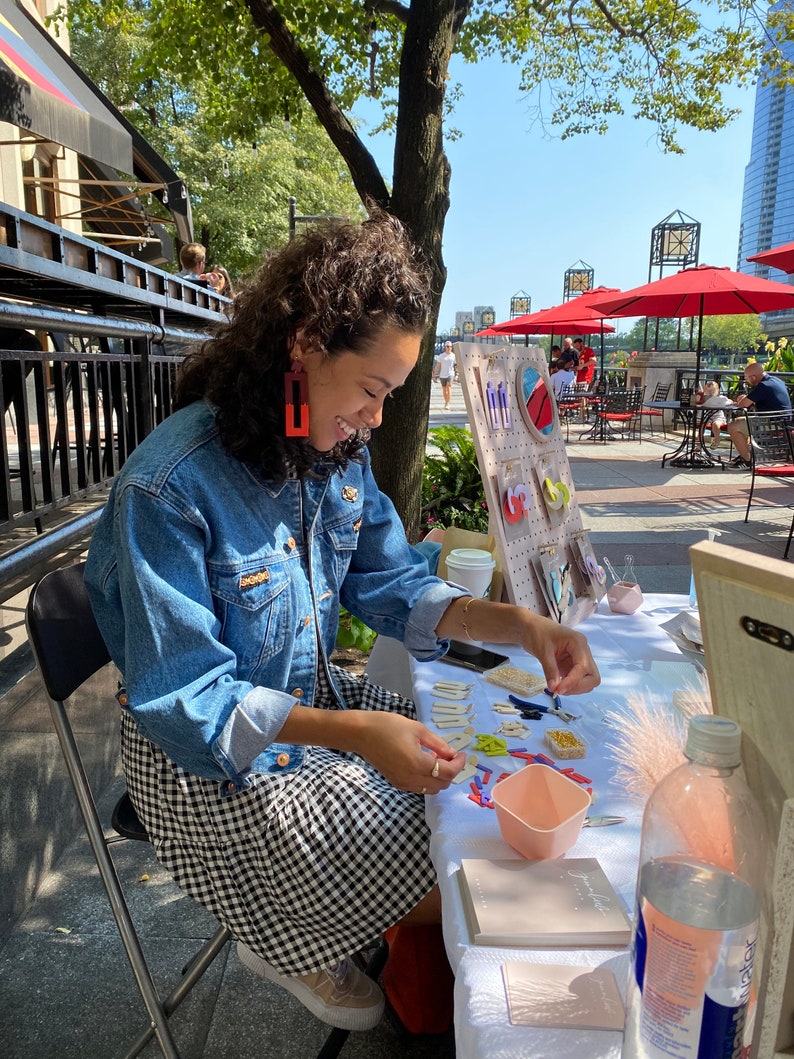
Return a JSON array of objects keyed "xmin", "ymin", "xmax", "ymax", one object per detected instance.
[{"xmin": 86, "ymin": 401, "xmax": 463, "ymax": 793}]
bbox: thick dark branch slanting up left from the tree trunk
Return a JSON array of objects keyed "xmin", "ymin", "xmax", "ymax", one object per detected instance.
[{"xmin": 246, "ymin": 0, "xmax": 390, "ymax": 208}]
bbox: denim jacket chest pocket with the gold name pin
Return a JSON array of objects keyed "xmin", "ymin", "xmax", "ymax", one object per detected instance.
[{"xmin": 207, "ymin": 556, "xmax": 294, "ymax": 679}]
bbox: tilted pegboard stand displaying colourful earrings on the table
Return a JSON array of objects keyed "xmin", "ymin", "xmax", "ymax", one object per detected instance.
[{"xmin": 455, "ymin": 342, "xmax": 602, "ymax": 626}]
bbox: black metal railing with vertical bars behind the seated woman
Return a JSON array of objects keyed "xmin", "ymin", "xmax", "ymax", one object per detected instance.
[{"xmin": 0, "ymin": 203, "xmax": 230, "ymax": 599}]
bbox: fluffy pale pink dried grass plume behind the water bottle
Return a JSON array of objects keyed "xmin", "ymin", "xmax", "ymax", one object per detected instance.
[{"xmin": 606, "ymin": 674, "xmax": 711, "ymax": 805}]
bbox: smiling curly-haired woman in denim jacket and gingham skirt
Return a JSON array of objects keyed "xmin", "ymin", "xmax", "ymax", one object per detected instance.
[{"xmin": 87, "ymin": 215, "xmax": 598, "ymax": 1029}]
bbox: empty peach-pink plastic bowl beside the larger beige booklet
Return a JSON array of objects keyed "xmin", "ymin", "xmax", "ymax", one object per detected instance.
[{"xmin": 491, "ymin": 765, "xmax": 590, "ymax": 860}]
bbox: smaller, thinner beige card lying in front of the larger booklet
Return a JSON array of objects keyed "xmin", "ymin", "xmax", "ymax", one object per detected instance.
[{"xmin": 502, "ymin": 962, "xmax": 626, "ymax": 1029}]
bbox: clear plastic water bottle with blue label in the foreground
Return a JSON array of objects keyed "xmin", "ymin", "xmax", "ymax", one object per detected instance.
[{"xmin": 622, "ymin": 715, "xmax": 766, "ymax": 1059}]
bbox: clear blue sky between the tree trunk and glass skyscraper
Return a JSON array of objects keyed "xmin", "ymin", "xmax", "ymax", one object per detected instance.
[{"xmin": 359, "ymin": 52, "xmax": 755, "ymax": 330}]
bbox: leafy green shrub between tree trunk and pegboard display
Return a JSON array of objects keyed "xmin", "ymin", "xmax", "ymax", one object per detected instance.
[{"xmin": 421, "ymin": 426, "xmax": 488, "ymax": 533}]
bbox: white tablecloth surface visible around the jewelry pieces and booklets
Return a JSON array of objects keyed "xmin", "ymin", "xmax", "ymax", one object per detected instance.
[{"xmin": 411, "ymin": 595, "xmax": 699, "ymax": 1059}]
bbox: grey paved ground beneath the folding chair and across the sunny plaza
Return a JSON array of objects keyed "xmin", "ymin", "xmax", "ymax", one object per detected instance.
[{"xmin": 0, "ymin": 387, "xmax": 794, "ymax": 1059}]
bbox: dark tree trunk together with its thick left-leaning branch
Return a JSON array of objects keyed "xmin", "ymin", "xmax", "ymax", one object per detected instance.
[{"xmin": 246, "ymin": 0, "xmax": 471, "ymax": 529}]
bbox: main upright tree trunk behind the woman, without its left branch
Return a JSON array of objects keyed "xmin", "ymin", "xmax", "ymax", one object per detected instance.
[{"xmin": 371, "ymin": 0, "xmax": 471, "ymax": 540}]
